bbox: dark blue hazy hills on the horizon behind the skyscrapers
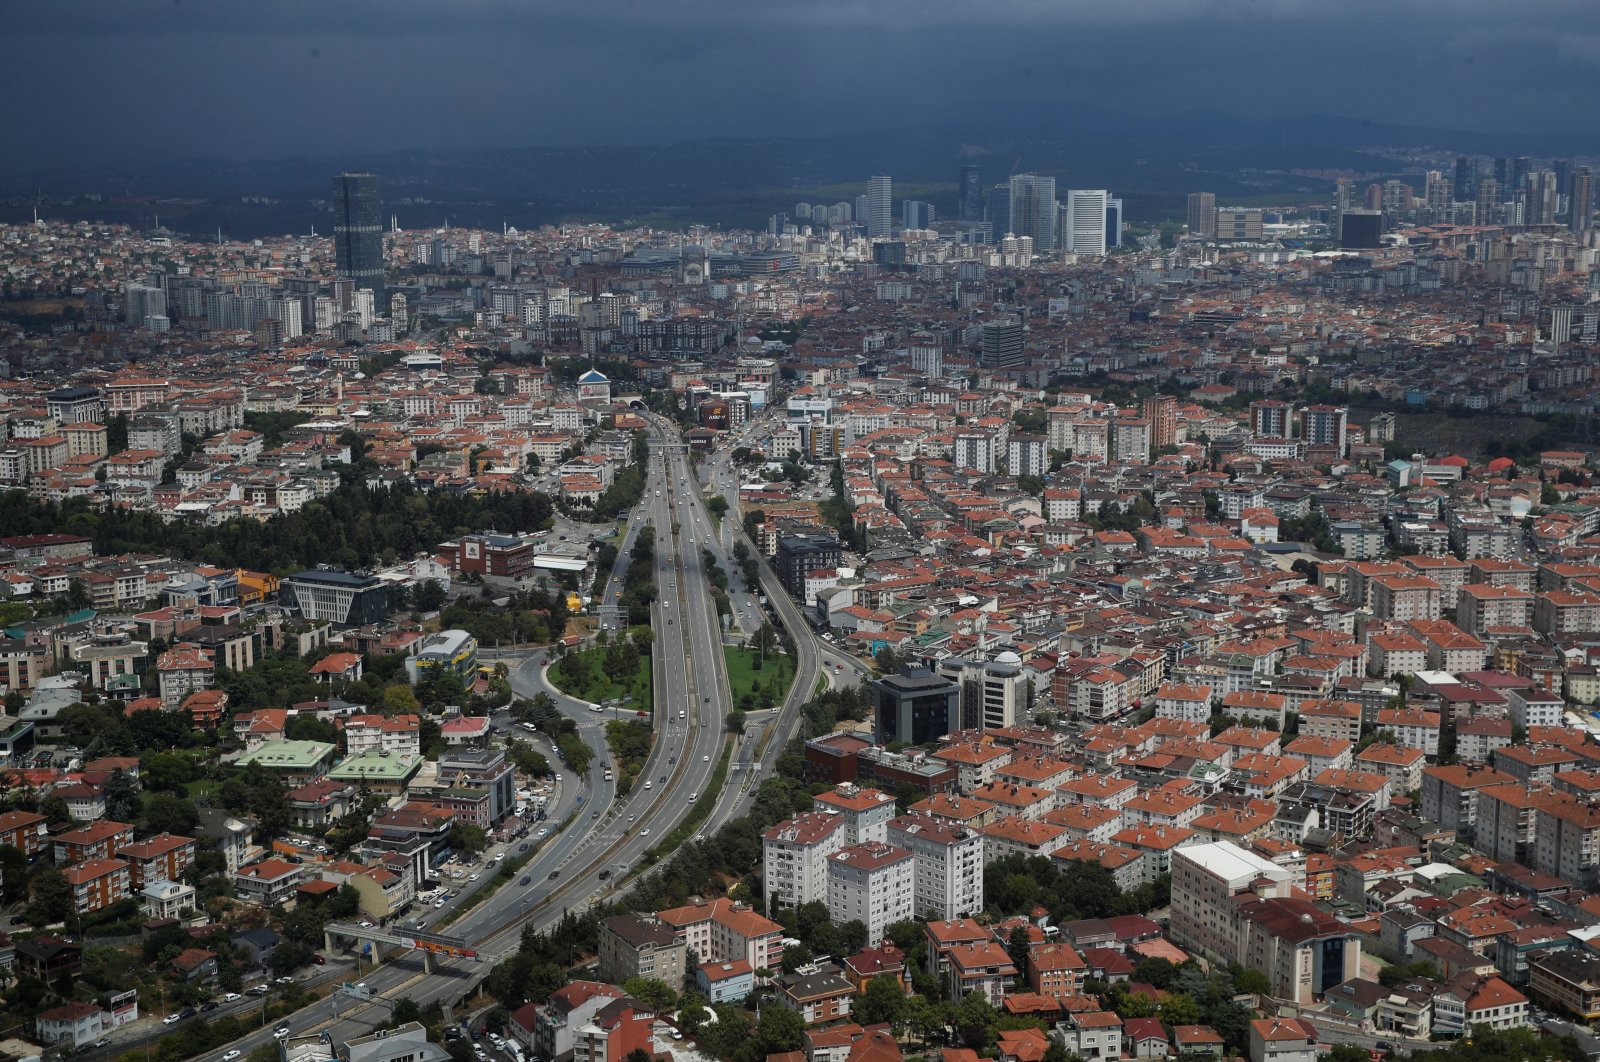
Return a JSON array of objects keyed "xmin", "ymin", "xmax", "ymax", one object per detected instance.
[{"xmin": 9, "ymin": 101, "xmax": 1595, "ymax": 237}]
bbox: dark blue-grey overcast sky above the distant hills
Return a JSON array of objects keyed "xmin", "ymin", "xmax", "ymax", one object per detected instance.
[{"xmin": 0, "ymin": 0, "xmax": 1600, "ymax": 171}]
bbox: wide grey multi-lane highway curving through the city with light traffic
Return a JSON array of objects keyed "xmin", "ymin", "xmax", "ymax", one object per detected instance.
[{"xmin": 198, "ymin": 415, "xmax": 742, "ymax": 1059}]
